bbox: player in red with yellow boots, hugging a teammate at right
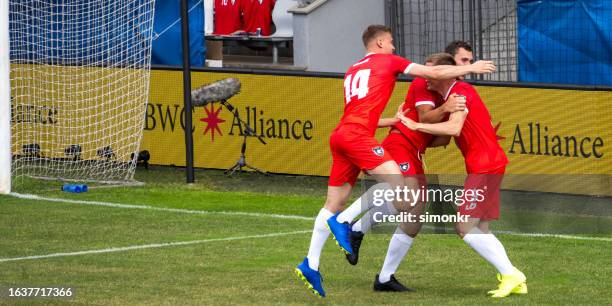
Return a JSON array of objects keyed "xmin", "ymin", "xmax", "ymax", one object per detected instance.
[{"xmin": 398, "ymin": 54, "xmax": 527, "ymax": 298}]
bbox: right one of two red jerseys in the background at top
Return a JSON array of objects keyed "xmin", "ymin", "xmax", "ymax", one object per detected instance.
[{"xmin": 242, "ymin": 0, "xmax": 276, "ymax": 36}]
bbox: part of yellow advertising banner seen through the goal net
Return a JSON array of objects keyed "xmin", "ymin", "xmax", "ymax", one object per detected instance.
[{"xmin": 11, "ymin": 64, "xmax": 148, "ymax": 163}]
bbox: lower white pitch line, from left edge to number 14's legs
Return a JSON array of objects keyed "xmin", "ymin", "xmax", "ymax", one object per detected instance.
[{"xmin": 0, "ymin": 230, "xmax": 311, "ymax": 263}]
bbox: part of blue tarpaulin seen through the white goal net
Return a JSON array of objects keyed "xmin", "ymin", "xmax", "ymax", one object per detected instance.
[{"xmin": 10, "ymin": 0, "xmax": 152, "ymax": 65}]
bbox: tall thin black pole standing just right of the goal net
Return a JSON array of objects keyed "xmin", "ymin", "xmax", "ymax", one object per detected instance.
[{"xmin": 181, "ymin": 0, "xmax": 195, "ymax": 183}]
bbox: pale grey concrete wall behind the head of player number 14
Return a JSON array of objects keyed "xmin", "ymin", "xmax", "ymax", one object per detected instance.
[{"xmin": 293, "ymin": 0, "xmax": 385, "ymax": 73}]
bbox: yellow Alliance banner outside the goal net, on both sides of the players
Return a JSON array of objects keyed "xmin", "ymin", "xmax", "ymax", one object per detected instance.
[{"xmin": 141, "ymin": 70, "xmax": 612, "ymax": 194}]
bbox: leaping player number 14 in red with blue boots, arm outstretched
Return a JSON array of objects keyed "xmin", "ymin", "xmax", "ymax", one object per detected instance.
[{"xmin": 296, "ymin": 25, "xmax": 495, "ymax": 296}]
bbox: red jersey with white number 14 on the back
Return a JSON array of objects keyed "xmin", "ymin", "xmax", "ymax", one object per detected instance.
[{"xmin": 338, "ymin": 53, "xmax": 412, "ymax": 136}]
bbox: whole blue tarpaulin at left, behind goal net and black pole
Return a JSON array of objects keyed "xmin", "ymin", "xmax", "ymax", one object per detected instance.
[{"xmin": 10, "ymin": 0, "xmax": 206, "ymax": 67}]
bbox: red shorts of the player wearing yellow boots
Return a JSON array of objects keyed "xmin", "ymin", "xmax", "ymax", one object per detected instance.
[{"xmin": 458, "ymin": 166, "xmax": 506, "ymax": 221}]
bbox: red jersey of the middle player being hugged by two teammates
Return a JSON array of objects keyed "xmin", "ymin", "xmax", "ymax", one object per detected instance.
[{"xmin": 395, "ymin": 78, "xmax": 443, "ymax": 154}]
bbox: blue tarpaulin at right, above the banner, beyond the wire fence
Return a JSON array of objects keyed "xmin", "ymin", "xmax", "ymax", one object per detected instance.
[{"xmin": 517, "ymin": 0, "xmax": 612, "ymax": 85}]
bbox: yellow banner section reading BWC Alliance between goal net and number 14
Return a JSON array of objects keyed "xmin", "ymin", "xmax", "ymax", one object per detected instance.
[{"xmin": 141, "ymin": 70, "xmax": 343, "ymax": 175}]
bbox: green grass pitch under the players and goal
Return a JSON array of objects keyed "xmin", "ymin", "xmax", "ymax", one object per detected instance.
[{"xmin": 0, "ymin": 168, "xmax": 612, "ymax": 305}]
